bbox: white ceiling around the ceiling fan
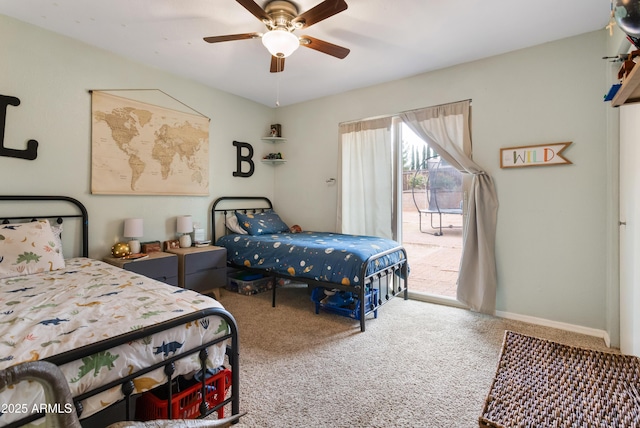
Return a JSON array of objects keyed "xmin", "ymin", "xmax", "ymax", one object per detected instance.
[{"xmin": 0, "ymin": 0, "xmax": 611, "ymax": 106}]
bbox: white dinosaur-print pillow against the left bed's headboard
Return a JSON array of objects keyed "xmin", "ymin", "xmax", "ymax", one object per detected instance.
[{"xmin": 0, "ymin": 220, "xmax": 65, "ymax": 278}]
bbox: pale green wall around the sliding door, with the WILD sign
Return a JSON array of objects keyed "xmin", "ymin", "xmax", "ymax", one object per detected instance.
[{"xmin": 275, "ymin": 31, "xmax": 617, "ymax": 343}]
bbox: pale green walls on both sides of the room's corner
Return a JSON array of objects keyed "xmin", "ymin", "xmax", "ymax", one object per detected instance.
[{"xmin": 0, "ymin": 16, "xmax": 618, "ymax": 344}]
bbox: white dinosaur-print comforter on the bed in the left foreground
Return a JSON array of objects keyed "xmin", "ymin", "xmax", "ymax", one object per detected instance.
[{"xmin": 0, "ymin": 258, "xmax": 227, "ymax": 426}]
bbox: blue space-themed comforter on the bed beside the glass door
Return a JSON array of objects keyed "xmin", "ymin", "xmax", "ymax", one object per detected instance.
[{"xmin": 216, "ymin": 232, "xmax": 404, "ymax": 286}]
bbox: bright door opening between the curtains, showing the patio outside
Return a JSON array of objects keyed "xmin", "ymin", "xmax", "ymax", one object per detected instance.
[{"xmin": 399, "ymin": 124, "xmax": 465, "ymax": 300}]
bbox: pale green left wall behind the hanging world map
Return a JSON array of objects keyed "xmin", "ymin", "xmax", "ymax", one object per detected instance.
[{"xmin": 0, "ymin": 15, "xmax": 274, "ymax": 258}]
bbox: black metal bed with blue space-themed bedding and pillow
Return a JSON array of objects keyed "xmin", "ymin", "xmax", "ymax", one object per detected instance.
[{"xmin": 211, "ymin": 196, "xmax": 409, "ymax": 332}]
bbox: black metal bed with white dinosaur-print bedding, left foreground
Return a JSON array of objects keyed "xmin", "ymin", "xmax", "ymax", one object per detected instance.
[{"xmin": 0, "ymin": 196, "xmax": 239, "ymax": 427}]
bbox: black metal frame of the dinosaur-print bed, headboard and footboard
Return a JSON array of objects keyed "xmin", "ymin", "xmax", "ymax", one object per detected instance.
[{"xmin": 0, "ymin": 195, "xmax": 240, "ymax": 428}]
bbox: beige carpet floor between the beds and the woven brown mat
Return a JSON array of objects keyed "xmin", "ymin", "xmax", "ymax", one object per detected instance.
[{"xmin": 216, "ymin": 288, "xmax": 607, "ymax": 428}]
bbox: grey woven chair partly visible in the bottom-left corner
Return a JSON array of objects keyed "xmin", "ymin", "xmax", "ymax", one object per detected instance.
[{"xmin": 0, "ymin": 361, "xmax": 241, "ymax": 428}]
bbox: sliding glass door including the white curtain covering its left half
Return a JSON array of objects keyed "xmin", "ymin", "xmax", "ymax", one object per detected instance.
[{"xmin": 339, "ymin": 117, "xmax": 465, "ymax": 299}]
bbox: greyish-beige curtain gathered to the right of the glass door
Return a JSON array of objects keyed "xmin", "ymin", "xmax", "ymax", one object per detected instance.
[{"xmin": 400, "ymin": 100, "xmax": 498, "ymax": 314}]
